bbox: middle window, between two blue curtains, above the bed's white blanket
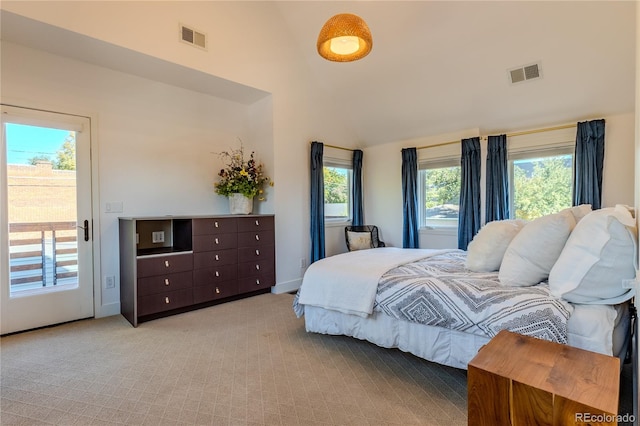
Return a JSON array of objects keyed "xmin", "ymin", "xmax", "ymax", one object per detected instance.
[{"xmin": 418, "ymin": 158, "xmax": 460, "ymax": 227}]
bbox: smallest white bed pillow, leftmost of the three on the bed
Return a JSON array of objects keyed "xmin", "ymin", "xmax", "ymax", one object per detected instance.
[{"xmin": 466, "ymin": 219, "xmax": 527, "ymax": 272}]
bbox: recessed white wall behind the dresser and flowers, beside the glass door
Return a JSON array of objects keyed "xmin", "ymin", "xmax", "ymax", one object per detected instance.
[{"xmin": 1, "ymin": 42, "xmax": 262, "ymax": 314}]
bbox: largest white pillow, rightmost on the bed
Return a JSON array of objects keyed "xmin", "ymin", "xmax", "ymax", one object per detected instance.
[{"xmin": 549, "ymin": 205, "xmax": 637, "ymax": 304}]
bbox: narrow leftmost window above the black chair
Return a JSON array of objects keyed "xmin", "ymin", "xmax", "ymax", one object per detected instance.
[{"xmin": 323, "ymin": 160, "xmax": 353, "ymax": 222}]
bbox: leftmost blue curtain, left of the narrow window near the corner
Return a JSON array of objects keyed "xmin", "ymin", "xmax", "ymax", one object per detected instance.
[{"xmin": 309, "ymin": 142, "xmax": 325, "ymax": 263}]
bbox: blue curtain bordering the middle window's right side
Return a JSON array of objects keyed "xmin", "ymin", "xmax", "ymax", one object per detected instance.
[{"xmin": 458, "ymin": 137, "xmax": 481, "ymax": 250}]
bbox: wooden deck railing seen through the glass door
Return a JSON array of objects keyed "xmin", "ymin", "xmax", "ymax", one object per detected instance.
[{"xmin": 9, "ymin": 222, "xmax": 78, "ymax": 290}]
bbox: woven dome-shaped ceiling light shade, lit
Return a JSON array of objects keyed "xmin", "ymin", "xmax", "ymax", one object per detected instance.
[{"xmin": 317, "ymin": 13, "xmax": 373, "ymax": 62}]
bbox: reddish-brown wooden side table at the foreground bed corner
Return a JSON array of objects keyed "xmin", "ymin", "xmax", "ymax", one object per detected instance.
[{"xmin": 467, "ymin": 330, "xmax": 620, "ymax": 426}]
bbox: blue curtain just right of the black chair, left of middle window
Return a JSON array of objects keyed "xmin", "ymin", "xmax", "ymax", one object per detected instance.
[{"xmin": 402, "ymin": 148, "xmax": 420, "ymax": 248}]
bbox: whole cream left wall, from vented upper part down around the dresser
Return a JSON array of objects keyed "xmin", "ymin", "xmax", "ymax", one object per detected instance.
[{"xmin": 2, "ymin": 2, "xmax": 355, "ymax": 308}]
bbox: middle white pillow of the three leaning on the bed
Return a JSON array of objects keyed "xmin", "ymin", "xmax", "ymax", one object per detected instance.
[{"xmin": 498, "ymin": 211, "xmax": 576, "ymax": 287}]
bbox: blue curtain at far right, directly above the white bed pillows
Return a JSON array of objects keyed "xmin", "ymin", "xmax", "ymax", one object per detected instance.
[{"xmin": 573, "ymin": 119, "xmax": 604, "ymax": 210}]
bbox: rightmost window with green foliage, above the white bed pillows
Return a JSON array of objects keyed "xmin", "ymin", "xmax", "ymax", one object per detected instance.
[{"xmin": 509, "ymin": 148, "xmax": 573, "ymax": 220}]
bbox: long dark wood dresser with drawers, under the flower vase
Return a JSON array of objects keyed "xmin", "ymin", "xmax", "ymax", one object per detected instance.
[{"xmin": 119, "ymin": 215, "xmax": 275, "ymax": 327}]
